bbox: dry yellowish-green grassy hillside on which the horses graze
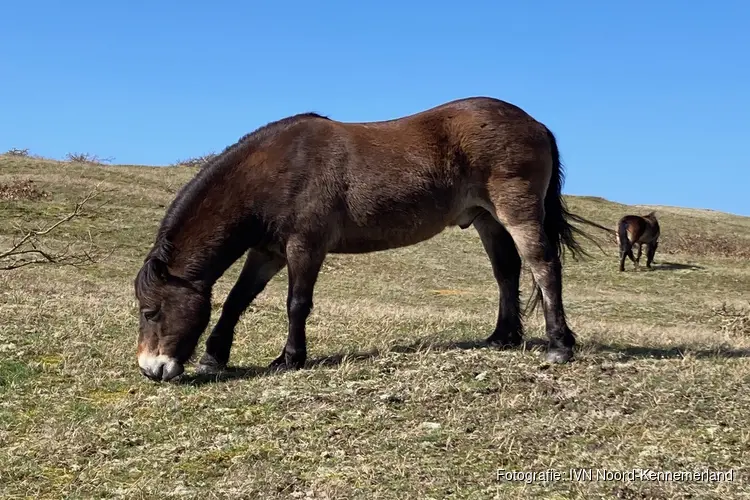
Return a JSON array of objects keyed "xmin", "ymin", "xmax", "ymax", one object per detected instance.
[{"xmin": 0, "ymin": 156, "xmax": 750, "ymax": 499}]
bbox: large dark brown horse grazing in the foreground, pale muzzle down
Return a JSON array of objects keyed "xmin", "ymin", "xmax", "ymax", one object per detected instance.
[{"xmin": 135, "ymin": 97, "xmax": 585, "ymax": 380}]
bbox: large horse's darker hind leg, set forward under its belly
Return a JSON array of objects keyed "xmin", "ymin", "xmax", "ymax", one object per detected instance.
[{"xmin": 474, "ymin": 212, "xmax": 523, "ymax": 346}]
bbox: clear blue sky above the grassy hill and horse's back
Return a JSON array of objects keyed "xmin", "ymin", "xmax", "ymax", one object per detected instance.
[{"xmin": 0, "ymin": 0, "xmax": 750, "ymax": 215}]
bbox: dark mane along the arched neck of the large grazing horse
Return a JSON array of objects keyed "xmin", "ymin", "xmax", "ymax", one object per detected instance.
[{"xmin": 147, "ymin": 112, "xmax": 330, "ymax": 263}]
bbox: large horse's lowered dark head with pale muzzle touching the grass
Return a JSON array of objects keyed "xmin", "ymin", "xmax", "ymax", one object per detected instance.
[{"xmin": 135, "ymin": 256, "xmax": 211, "ymax": 381}]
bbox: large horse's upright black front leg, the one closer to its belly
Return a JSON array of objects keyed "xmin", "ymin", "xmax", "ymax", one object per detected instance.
[{"xmin": 271, "ymin": 236, "xmax": 326, "ymax": 370}]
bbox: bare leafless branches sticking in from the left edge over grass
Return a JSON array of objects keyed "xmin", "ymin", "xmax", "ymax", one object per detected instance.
[{"xmin": 0, "ymin": 190, "xmax": 111, "ymax": 271}]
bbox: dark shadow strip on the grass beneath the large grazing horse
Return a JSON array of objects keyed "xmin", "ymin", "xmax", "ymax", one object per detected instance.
[{"xmin": 178, "ymin": 337, "xmax": 750, "ymax": 386}]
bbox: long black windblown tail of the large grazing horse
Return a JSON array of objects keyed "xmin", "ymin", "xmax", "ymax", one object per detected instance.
[{"xmin": 526, "ymin": 127, "xmax": 592, "ymax": 312}]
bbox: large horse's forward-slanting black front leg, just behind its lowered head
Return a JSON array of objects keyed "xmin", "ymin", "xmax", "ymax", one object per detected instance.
[{"xmin": 198, "ymin": 250, "xmax": 285, "ymax": 373}]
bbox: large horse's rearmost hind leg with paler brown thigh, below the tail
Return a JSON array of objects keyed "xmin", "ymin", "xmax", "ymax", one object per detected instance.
[{"xmin": 495, "ymin": 194, "xmax": 575, "ymax": 363}]
